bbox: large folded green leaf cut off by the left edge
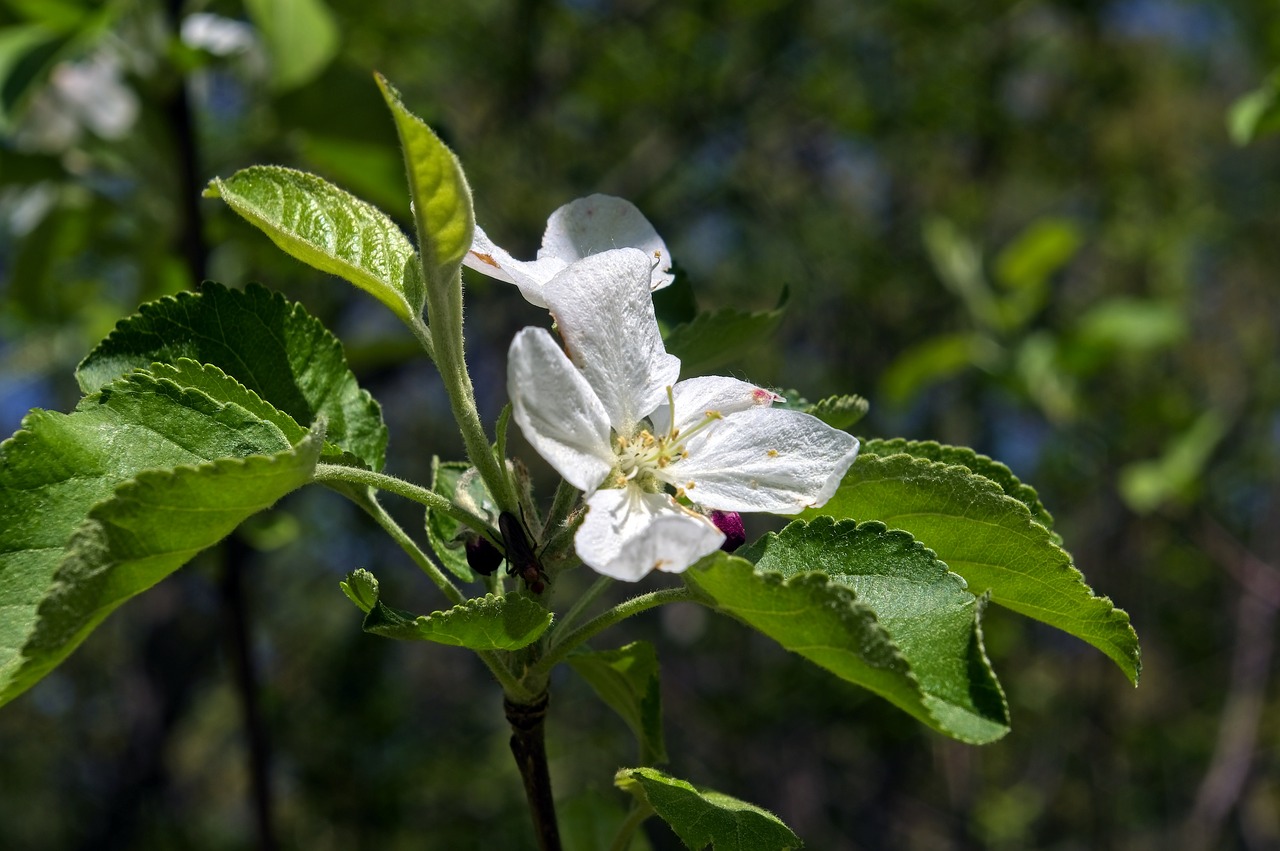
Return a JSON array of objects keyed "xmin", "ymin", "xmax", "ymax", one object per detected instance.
[{"xmin": 0, "ymin": 414, "xmax": 324, "ymax": 705}]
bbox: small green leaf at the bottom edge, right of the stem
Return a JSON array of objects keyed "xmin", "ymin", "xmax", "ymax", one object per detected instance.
[{"xmin": 613, "ymin": 768, "xmax": 801, "ymax": 851}]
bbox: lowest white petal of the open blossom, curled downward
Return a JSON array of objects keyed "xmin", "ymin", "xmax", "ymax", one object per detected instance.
[{"xmin": 573, "ymin": 486, "xmax": 724, "ymax": 582}]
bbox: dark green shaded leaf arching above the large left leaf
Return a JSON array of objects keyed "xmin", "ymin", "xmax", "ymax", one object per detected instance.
[{"xmin": 76, "ymin": 282, "xmax": 387, "ymax": 470}]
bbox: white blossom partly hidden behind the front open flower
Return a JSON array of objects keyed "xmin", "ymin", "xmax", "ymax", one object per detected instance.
[{"xmin": 462, "ymin": 195, "xmax": 675, "ymax": 307}]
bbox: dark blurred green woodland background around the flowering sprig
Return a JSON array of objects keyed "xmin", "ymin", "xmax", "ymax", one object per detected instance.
[{"xmin": 0, "ymin": 0, "xmax": 1280, "ymax": 851}]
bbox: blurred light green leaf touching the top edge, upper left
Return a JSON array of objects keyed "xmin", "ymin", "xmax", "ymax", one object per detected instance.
[{"xmin": 244, "ymin": 0, "xmax": 339, "ymax": 92}]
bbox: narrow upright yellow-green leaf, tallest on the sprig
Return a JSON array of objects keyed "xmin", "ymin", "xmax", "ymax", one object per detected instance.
[{"xmin": 376, "ymin": 74, "xmax": 475, "ymax": 288}]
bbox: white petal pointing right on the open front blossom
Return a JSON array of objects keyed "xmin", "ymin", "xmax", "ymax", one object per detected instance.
[{"xmin": 660, "ymin": 408, "xmax": 858, "ymax": 514}]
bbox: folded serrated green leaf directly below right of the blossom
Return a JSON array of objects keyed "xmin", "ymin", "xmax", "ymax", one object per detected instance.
[{"xmin": 685, "ymin": 532, "xmax": 1009, "ymax": 744}]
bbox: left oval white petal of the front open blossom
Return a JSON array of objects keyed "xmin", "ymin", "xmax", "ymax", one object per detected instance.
[{"xmin": 507, "ymin": 328, "xmax": 614, "ymax": 493}]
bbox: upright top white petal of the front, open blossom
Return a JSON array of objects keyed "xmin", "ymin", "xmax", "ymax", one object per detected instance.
[{"xmin": 543, "ymin": 248, "xmax": 680, "ymax": 436}]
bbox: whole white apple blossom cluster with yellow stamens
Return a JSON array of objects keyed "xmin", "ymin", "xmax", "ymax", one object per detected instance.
[{"xmin": 465, "ymin": 195, "xmax": 858, "ymax": 581}]
